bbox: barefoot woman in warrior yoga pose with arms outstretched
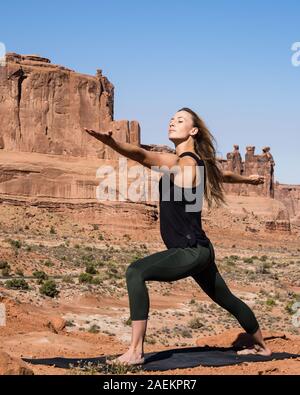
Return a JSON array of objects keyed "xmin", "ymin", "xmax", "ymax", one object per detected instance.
[{"xmin": 84, "ymin": 107, "xmax": 271, "ymax": 365}]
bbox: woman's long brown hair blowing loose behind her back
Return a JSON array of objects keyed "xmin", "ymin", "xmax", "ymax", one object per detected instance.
[{"xmin": 178, "ymin": 107, "xmax": 227, "ymax": 208}]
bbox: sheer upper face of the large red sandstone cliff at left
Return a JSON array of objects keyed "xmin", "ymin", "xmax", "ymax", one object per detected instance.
[{"xmin": 0, "ymin": 53, "xmax": 140, "ymax": 159}]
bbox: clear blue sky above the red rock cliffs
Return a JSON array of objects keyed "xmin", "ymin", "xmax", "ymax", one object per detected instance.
[{"xmin": 0, "ymin": 0, "xmax": 300, "ymax": 184}]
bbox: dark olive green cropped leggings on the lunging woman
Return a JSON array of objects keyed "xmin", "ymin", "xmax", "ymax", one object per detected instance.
[{"xmin": 126, "ymin": 243, "xmax": 259, "ymax": 334}]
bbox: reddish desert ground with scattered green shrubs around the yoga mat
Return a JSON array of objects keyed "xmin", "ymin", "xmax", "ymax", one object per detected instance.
[{"xmin": 0, "ymin": 202, "xmax": 300, "ymax": 375}]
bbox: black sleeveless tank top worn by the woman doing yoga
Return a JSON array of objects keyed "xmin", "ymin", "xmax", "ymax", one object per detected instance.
[{"xmin": 159, "ymin": 152, "xmax": 210, "ymax": 249}]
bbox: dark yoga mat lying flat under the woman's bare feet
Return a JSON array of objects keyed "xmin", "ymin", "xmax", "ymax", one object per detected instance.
[{"xmin": 22, "ymin": 346, "xmax": 300, "ymax": 371}]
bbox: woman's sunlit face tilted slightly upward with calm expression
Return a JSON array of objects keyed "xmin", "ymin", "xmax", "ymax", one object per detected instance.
[{"xmin": 169, "ymin": 111, "xmax": 197, "ymax": 142}]
